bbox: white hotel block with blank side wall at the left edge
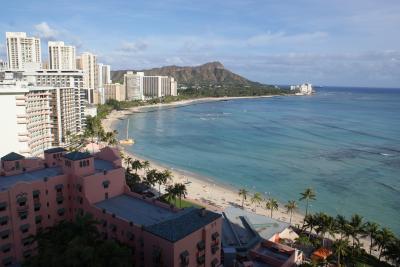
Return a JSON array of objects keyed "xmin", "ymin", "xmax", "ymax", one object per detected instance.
[{"xmin": 0, "ymin": 80, "xmax": 53, "ymax": 156}]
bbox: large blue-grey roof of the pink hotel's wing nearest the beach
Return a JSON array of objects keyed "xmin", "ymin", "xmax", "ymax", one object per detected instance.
[{"xmin": 95, "ymin": 195, "xmax": 221, "ymax": 242}]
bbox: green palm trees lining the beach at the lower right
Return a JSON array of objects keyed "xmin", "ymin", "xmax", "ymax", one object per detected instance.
[{"xmin": 239, "ymin": 188, "xmax": 400, "ymax": 267}]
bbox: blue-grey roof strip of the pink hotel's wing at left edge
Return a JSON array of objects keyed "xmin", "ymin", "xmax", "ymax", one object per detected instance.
[{"xmin": 0, "ymin": 167, "xmax": 62, "ymax": 191}]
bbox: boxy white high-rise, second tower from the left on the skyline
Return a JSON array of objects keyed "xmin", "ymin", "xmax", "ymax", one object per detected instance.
[{"xmin": 48, "ymin": 41, "xmax": 76, "ymax": 70}]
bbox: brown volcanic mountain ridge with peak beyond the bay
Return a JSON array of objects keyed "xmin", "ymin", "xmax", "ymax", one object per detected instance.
[{"xmin": 111, "ymin": 62, "xmax": 293, "ymax": 97}]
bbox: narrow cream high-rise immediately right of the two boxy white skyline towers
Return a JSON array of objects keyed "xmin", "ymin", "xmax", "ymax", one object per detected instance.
[{"xmin": 76, "ymin": 52, "xmax": 98, "ymax": 104}]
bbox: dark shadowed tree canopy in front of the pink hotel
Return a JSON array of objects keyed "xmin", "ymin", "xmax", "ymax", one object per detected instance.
[{"xmin": 22, "ymin": 214, "xmax": 132, "ymax": 267}]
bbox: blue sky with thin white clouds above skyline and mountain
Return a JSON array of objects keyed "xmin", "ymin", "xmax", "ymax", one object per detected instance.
[{"xmin": 0, "ymin": 0, "xmax": 400, "ymax": 88}]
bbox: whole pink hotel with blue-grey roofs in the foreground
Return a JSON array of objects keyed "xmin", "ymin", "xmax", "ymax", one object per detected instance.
[{"xmin": 0, "ymin": 148, "xmax": 222, "ymax": 267}]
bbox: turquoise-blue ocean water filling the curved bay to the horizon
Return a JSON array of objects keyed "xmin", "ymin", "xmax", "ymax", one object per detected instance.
[{"xmin": 116, "ymin": 88, "xmax": 400, "ymax": 234}]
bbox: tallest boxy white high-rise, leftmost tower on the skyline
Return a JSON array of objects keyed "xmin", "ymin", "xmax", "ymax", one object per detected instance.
[{"xmin": 6, "ymin": 32, "xmax": 42, "ymax": 70}]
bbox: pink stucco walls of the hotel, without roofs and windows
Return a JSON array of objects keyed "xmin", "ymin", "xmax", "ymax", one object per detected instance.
[{"xmin": 0, "ymin": 148, "xmax": 222, "ymax": 267}]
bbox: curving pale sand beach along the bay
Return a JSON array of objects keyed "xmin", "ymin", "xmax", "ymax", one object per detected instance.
[{"xmin": 102, "ymin": 95, "xmax": 304, "ymax": 225}]
